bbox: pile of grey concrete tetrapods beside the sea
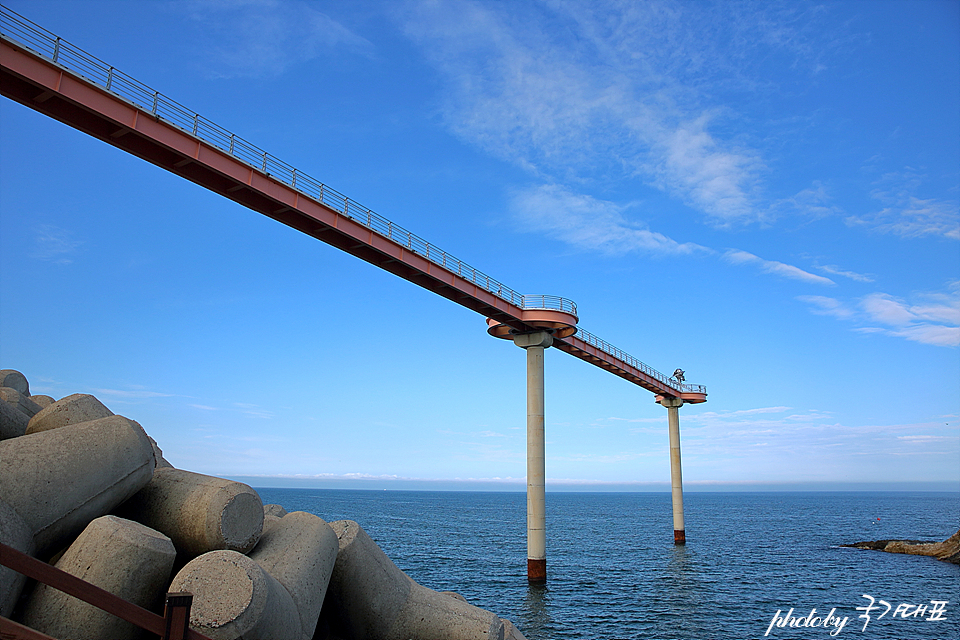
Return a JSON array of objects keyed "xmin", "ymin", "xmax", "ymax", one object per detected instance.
[{"xmin": 0, "ymin": 369, "xmax": 523, "ymax": 640}]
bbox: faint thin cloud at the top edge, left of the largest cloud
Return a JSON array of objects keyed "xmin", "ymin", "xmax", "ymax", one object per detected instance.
[{"xmin": 186, "ymin": 0, "xmax": 374, "ymax": 78}]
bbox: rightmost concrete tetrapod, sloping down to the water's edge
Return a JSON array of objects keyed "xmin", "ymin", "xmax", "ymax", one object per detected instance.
[{"xmin": 324, "ymin": 516, "xmax": 504, "ymax": 640}]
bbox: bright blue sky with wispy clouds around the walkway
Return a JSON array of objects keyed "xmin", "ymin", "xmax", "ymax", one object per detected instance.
[{"xmin": 0, "ymin": 0, "xmax": 960, "ymax": 490}]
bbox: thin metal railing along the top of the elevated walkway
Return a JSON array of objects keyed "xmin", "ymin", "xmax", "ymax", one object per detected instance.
[{"xmin": 0, "ymin": 5, "xmax": 706, "ymax": 393}]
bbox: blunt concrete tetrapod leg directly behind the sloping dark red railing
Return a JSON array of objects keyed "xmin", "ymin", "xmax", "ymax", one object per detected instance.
[{"xmin": 23, "ymin": 516, "xmax": 177, "ymax": 640}]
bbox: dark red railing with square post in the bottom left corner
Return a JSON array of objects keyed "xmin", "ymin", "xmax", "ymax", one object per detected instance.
[{"xmin": 0, "ymin": 542, "xmax": 211, "ymax": 640}]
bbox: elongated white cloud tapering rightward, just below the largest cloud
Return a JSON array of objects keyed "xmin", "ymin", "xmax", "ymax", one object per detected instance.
[{"xmin": 511, "ymin": 185, "xmax": 710, "ymax": 254}]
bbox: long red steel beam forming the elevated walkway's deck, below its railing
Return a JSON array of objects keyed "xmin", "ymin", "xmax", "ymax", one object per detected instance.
[{"xmin": 0, "ymin": 35, "xmax": 706, "ymax": 402}]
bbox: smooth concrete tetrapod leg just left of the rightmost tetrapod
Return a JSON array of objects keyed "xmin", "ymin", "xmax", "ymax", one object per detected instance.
[{"xmin": 249, "ymin": 511, "xmax": 339, "ymax": 640}]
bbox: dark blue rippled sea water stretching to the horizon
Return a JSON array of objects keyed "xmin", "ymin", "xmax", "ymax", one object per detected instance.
[{"xmin": 258, "ymin": 489, "xmax": 960, "ymax": 640}]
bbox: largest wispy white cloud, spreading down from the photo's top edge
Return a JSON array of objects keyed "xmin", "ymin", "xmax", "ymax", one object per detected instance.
[{"xmin": 405, "ymin": 0, "xmax": 823, "ymax": 226}]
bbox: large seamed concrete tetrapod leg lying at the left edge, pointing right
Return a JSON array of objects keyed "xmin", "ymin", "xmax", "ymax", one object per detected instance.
[{"xmin": 0, "ymin": 416, "xmax": 155, "ymax": 555}]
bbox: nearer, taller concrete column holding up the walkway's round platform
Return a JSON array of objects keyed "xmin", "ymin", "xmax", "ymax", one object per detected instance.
[{"xmin": 513, "ymin": 331, "xmax": 553, "ymax": 584}]
